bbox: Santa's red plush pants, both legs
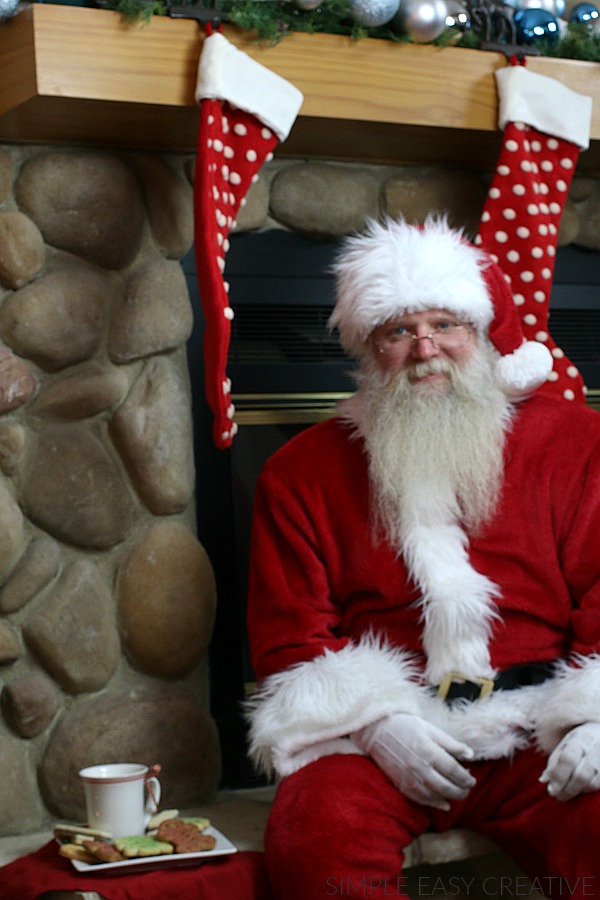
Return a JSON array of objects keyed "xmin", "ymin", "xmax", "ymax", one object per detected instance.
[{"xmin": 265, "ymin": 750, "xmax": 600, "ymax": 900}]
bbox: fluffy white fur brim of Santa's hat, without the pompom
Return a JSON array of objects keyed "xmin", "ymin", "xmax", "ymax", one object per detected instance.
[{"xmin": 329, "ymin": 218, "xmax": 494, "ymax": 356}]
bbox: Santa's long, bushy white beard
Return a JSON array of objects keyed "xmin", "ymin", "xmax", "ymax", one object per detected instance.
[{"xmin": 358, "ymin": 348, "xmax": 512, "ymax": 547}]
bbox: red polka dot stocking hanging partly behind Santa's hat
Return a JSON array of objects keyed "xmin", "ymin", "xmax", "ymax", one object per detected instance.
[{"xmin": 475, "ymin": 59, "xmax": 591, "ymax": 401}]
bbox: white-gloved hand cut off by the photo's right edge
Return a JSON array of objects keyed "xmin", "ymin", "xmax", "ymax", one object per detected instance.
[{"xmin": 540, "ymin": 722, "xmax": 600, "ymax": 800}]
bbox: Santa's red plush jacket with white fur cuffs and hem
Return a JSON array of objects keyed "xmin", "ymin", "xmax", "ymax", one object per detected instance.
[{"xmin": 248, "ymin": 395, "xmax": 600, "ymax": 775}]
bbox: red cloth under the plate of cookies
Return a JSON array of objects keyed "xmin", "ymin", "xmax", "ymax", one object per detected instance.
[{"xmin": 0, "ymin": 841, "xmax": 272, "ymax": 900}]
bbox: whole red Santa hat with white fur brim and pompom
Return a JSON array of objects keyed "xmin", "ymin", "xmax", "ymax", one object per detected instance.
[{"xmin": 330, "ymin": 217, "xmax": 552, "ymax": 396}]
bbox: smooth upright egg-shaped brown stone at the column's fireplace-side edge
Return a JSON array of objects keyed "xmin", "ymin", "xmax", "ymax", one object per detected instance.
[{"xmin": 117, "ymin": 522, "xmax": 216, "ymax": 678}]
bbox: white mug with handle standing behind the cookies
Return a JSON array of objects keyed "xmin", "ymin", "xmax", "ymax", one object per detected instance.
[{"xmin": 79, "ymin": 763, "xmax": 161, "ymax": 839}]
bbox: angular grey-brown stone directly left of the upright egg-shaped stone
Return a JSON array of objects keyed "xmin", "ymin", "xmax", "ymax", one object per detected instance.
[{"xmin": 23, "ymin": 560, "xmax": 121, "ymax": 694}]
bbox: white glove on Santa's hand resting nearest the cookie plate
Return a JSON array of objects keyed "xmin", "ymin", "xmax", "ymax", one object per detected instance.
[{"xmin": 352, "ymin": 713, "xmax": 475, "ymax": 810}]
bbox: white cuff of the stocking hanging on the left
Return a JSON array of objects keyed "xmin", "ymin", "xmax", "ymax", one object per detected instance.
[{"xmin": 195, "ymin": 31, "xmax": 304, "ymax": 141}]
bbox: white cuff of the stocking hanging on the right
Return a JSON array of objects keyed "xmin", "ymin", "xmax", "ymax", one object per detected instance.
[{"xmin": 495, "ymin": 66, "xmax": 592, "ymax": 150}]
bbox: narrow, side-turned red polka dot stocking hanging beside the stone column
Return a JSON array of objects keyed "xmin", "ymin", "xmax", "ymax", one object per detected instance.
[{"xmin": 194, "ymin": 32, "xmax": 303, "ymax": 448}]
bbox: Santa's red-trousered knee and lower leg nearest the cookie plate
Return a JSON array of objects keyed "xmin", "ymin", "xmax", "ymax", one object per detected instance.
[{"xmin": 265, "ymin": 755, "xmax": 410, "ymax": 900}]
